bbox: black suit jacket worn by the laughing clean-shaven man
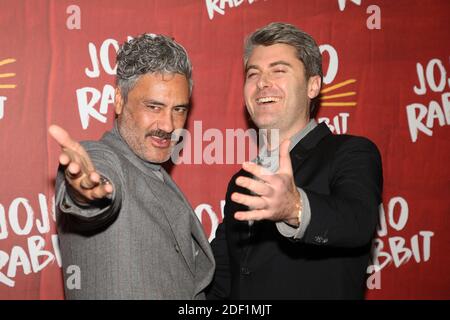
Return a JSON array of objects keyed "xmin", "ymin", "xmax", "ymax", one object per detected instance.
[{"xmin": 208, "ymin": 124, "xmax": 382, "ymax": 299}]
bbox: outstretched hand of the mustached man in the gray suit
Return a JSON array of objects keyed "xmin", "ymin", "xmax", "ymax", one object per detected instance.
[{"xmin": 48, "ymin": 125, "xmax": 113, "ymax": 204}]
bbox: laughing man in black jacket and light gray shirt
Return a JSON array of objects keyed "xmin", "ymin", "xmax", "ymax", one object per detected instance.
[{"xmin": 208, "ymin": 23, "xmax": 382, "ymax": 299}]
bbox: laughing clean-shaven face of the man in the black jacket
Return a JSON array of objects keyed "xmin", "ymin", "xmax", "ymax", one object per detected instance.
[{"xmin": 244, "ymin": 43, "xmax": 320, "ymax": 141}]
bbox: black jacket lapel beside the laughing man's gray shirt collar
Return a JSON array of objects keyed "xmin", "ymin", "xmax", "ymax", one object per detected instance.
[{"xmin": 290, "ymin": 122, "xmax": 331, "ymax": 176}]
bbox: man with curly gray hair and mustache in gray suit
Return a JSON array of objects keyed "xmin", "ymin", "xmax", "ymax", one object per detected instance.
[{"xmin": 49, "ymin": 34, "xmax": 214, "ymax": 299}]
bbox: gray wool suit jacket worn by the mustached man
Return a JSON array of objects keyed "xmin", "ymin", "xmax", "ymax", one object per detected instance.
[{"xmin": 56, "ymin": 127, "xmax": 215, "ymax": 299}]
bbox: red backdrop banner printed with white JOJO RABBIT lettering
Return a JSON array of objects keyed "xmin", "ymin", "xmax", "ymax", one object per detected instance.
[{"xmin": 0, "ymin": 0, "xmax": 450, "ymax": 299}]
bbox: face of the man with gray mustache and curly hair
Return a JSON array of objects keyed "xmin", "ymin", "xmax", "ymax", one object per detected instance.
[{"xmin": 115, "ymin": 73, "xmax": 189, "ymax": 163}]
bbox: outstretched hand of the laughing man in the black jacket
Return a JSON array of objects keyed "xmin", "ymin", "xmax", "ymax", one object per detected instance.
[{"xmin": 231, "ymin": 140, "xmax": 300, "ymax": 225}]
